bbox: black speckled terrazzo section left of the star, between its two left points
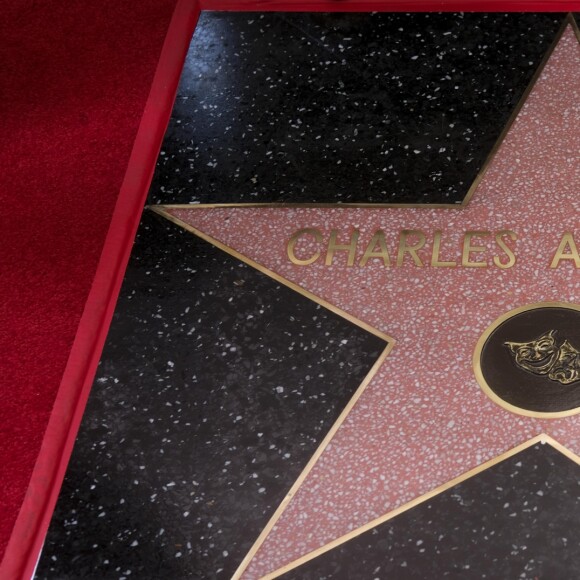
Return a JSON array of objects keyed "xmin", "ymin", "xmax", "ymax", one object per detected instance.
[{"xmin": 37, "ymin": 213, "xmax": 385, "ymax": 579}]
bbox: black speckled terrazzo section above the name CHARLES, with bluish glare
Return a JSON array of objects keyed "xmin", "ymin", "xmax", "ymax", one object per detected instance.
[{"xmin": 150, "ymin": 12, "xmax": 564, "ymax": 203}]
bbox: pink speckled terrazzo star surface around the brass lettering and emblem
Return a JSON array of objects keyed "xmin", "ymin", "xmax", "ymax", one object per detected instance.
[{"xmin": 156, "ymin": 26, "xmax": 580, "ymax": 578}]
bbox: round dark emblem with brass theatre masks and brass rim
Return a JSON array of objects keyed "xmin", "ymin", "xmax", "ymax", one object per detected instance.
[{"xmin": 473, "ymin": 302, "xmax": 580, "ymax": 419}]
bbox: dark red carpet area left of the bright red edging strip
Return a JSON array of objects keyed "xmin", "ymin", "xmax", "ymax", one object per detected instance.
[{"xmin": 0, "ymin": 0, "xmax": 176, "ymax": 572}]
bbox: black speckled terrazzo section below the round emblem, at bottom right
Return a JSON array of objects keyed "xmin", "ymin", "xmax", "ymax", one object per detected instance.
[{"xmin": 280, "ymin": 445, "xmax": 580, "ymax": 580}]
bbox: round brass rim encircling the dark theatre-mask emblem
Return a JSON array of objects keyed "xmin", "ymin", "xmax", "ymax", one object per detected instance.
[{"xmin": 472, "ymin": 302, "xmax": 580, "ymax": 419}]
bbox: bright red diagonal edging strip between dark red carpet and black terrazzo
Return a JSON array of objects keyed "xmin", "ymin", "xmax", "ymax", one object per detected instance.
[{"xmin": 0, "ymin": 0, "xmax": 200, "ymax": 579}]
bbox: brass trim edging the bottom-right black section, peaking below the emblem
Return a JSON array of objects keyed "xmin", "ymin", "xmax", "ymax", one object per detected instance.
[{"xmin": 260, "ymin": 433, "xmax": 580, "ymax": 580}]
